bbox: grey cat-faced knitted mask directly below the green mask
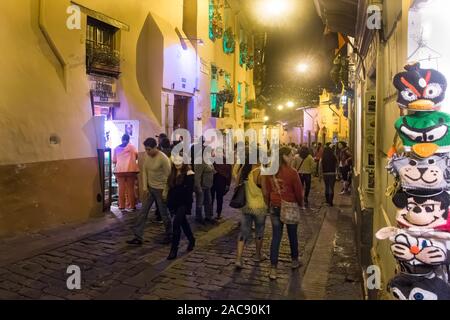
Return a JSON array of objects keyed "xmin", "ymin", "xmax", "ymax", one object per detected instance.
[{"xmin": 387, "ymin": 156, "xmax": 449, "ymax": 191}]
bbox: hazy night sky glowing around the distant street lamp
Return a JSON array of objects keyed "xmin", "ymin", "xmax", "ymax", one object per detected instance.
[{"xmin": 250, "ymin": 0, "xmax": 337, "ymax": 120}]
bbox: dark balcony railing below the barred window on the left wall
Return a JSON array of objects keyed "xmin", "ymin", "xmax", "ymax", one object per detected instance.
[{"xmin": 86, "ymin": 41, "xmax": 120, "ymax": 78}]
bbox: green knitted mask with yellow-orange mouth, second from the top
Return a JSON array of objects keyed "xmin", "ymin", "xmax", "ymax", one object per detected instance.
[{"xmin": 395, "ymin": 112, "xmax": 450, "ymax": 158}]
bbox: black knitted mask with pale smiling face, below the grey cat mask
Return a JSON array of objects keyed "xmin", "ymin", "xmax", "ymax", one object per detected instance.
[{"xmin": 392, "ymin": 190, "xmax": 450, "ymax": 230}]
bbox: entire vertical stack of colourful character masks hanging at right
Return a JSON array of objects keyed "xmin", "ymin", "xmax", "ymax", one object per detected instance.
[{"xmin": 375, "ymin": 63, "xmax": 450, "ymax": 300}]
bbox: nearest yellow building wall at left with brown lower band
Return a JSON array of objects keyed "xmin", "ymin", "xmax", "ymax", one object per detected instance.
[{"xmin": 0, "ymin": 0, "xmax": 192, "ymax": 237}]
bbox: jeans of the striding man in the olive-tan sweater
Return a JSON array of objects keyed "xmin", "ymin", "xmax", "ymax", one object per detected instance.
[{"xmin": 133, "ymin": 188, "xmax": 172, "ymax": 240}]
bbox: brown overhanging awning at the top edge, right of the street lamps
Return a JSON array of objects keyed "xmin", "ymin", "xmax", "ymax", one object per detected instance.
[{"xmin": 314, "ymin": 0, "xmax": 359, "ymax": 37}]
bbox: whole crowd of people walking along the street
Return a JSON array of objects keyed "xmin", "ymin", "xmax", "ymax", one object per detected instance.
[{"xmin": 113, "ymin": 134, "xmax": 352, "ymax": 280}]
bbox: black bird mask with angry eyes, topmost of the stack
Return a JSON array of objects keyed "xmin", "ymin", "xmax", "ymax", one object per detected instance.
[{"xmin": 394, "ymin": 63, "xmax": 447, "ymax": 111}]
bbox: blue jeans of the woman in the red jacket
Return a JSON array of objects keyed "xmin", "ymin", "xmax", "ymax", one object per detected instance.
[{"xmin": 270, "ymin": 208, "xmax": 298, "ymax": 266}]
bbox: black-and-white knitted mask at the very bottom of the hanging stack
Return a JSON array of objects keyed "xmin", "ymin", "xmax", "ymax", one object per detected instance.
[{"xmin": 388, "ymin": 274, "xmax": 450, "ymax": 300}]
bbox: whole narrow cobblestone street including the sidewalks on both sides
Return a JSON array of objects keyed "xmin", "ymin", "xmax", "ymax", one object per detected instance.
[{"xmin": 0, "ymin": 181, "xmax": 362, "ymax": 300}]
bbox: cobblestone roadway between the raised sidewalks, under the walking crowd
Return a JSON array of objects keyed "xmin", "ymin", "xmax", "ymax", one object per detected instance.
[{"xmin": 0, "ymin": 183, "xmax": 362, "ymax": 300}]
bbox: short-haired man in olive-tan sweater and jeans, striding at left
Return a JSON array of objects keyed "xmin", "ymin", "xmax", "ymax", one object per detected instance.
[{"xmin": 127, "ymin": 138, "xmax": 172, "ymax": 245}]
